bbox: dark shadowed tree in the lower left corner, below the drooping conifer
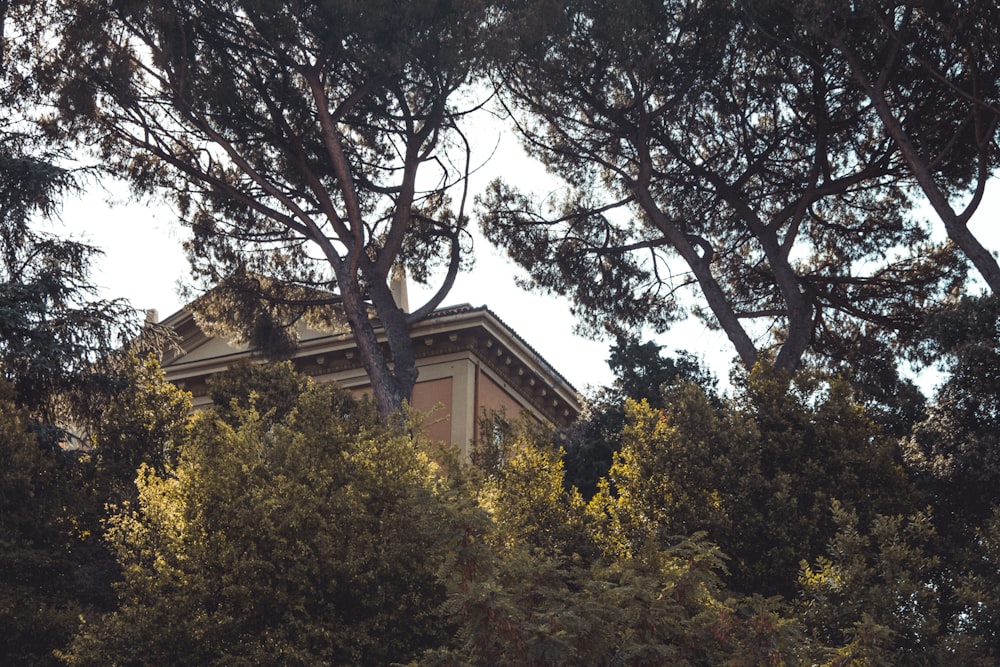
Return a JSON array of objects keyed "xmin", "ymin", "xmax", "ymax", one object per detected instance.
[{"xmin": 0, "ymin": 357, "xmax": 190, "ymax": 665}]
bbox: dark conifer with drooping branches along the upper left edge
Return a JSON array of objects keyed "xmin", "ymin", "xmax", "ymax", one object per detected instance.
[{"xmin": 0, "ymin": 13, "xmax": 139, "ymax": 424}]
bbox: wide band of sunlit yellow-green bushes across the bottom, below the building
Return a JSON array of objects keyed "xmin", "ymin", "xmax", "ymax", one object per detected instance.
[{"xmin": 0, "ymin": 365, "xmax": 964, "ymax": 665}]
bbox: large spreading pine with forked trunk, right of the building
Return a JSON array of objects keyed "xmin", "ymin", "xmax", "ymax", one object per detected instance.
[{"xmin": 480, "ymin": 0, "xmax": 962, "ymax": 370}]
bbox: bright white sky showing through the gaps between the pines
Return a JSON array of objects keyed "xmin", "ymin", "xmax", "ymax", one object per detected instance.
[{"xmin": 53, "ymin": 127, "xmax": 1000, "ymax": 393}]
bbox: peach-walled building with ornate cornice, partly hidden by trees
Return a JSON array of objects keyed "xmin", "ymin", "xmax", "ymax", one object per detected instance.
[{"xmin": 155, "ymin": 305, "xmax": 580, "ymax": 452}]
